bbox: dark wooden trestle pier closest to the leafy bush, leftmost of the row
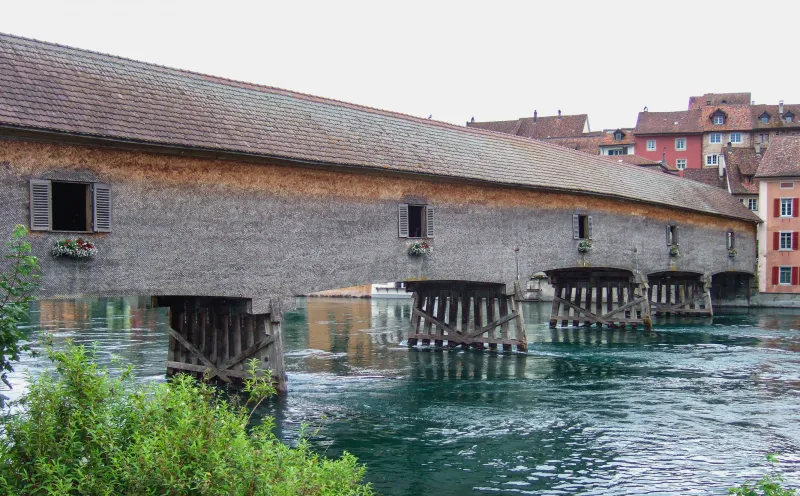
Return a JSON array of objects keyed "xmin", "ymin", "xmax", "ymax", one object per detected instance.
[{"xmin": 154, "ymin": 296, "xmax": 286, "ymax": 393}]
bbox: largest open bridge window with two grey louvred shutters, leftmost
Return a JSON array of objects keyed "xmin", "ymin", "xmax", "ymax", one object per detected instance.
[{"xmin": 30, "ymin": 179, "xmax": 111, "ymax": 232}]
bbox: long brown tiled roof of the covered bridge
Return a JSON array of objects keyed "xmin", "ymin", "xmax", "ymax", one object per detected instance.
[{"xmin": 0, "ymin": 34, "xmax": 759, "ymax": 222}]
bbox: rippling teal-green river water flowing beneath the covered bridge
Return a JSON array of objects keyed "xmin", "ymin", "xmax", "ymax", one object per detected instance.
[{"xmin": 5, "ymin": 298, "xmax": 800, "ymax": 495}]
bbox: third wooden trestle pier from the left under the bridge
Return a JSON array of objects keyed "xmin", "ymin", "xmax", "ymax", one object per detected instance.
[{"xmin": 550, "ymin": 269, "xmax": 653, "ymax": 329}]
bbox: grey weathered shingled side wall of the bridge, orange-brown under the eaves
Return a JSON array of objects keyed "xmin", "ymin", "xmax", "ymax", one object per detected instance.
[{"xmin": 0, "ymin": 140, "xmax": 756, "ymax": 313}]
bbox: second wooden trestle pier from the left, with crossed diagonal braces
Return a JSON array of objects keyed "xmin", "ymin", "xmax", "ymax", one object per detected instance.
[{"xmin": 408, "ymin": 281, "xmax": 528, "ymax": 352}]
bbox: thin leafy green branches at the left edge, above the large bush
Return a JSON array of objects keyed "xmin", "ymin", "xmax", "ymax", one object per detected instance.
[{"xmin": 0, "ymin": 224, "xmax": 39, "ymax": 387}]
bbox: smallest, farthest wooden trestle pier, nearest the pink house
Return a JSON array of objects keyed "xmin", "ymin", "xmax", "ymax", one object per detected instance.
[{"xmin": 648, "ymin": 272, "xmax": 714, "ymax": 316}]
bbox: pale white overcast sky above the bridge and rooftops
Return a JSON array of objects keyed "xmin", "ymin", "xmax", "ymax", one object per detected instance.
[{"xmin": 0, "ymin": 0, "xmax": 800, "ymax": 130}]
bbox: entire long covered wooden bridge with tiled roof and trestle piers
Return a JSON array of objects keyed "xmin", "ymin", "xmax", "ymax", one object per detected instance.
[{"xmin": 0, "ymin": 35, "xmax": 758, "ymax": 392}]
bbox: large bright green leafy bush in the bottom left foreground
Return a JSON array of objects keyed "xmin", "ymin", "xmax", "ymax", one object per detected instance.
[{"xmin": 0, "ymin": 344, "xmax": 372, "ymax": 496}]
